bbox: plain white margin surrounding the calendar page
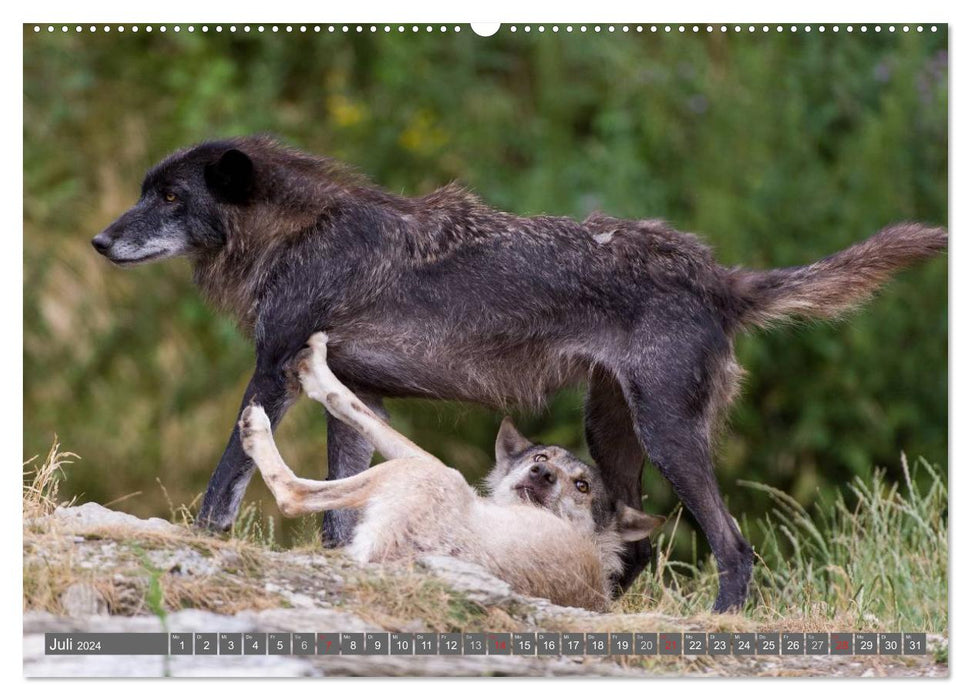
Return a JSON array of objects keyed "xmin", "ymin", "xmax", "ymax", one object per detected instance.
[{"xmin": 0, "ymin": 0, "xmax": 971, "ymax": 700}]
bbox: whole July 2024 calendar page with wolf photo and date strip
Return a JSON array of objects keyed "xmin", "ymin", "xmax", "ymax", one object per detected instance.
[{"xmin": 22, "ymin": 6, "xmax": 949, "ymax": 678}]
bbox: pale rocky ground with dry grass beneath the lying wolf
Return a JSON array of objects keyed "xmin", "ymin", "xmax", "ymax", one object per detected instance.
[{"xmin": 24, "ymin": 503, "xmax": 948, "ymax": 677}]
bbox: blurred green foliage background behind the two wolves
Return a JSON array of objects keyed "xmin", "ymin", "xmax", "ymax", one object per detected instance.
[{"xmin": 24, "ymin": 27, "xmax": 948, "ymax": 551}]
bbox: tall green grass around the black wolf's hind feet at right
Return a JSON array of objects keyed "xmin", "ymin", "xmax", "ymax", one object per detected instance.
[{"xmin": 619, "ymin": 458, "xmax": 948, "ymax": 633}]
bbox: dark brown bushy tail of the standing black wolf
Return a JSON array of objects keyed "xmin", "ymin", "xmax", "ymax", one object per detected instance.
[{"xmin": 730, "ymin": 223, "xmax": 947, "ymax": 326}]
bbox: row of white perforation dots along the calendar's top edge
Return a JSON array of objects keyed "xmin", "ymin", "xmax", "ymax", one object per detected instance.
[{"xmin": 34, "ymin": 24, "xmax": 937, "ymax": 34}]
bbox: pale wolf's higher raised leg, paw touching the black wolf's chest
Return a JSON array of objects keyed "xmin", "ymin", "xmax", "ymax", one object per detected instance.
[{"xmin": 297, "ymin": 333, "xmax": 438, "ymax": 462}]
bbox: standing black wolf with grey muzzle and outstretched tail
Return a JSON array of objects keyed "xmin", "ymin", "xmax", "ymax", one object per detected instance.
[{"xmin": 93, "ymin": 137, "xmax": 947, "ymax": 611}]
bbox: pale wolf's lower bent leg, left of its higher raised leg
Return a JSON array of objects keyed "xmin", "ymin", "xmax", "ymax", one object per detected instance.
[{"xmin": 239, "ymin": 405, "xmax": 378, "ymax": 518}]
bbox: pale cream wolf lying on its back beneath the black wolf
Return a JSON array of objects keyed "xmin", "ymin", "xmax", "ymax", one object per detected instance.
[{"xmin": 239, "ymin": 333, "xmax": 663, "ymax": 610}]
